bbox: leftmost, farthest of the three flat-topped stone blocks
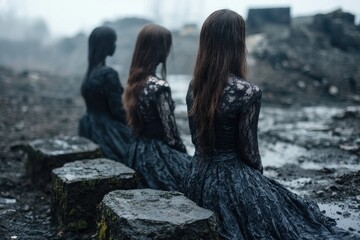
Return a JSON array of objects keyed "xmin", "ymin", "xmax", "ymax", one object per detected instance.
[{"xmin": 22, "ymin": 136, "xmax": 102, "ymax": 187}]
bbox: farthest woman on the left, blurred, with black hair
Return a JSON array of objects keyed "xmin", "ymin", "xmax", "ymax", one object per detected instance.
[{"xmin": 79, "ymin": 27, "xmax": 131, "ymax": 162}]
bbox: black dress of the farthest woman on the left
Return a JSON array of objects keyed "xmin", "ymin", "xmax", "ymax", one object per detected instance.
[{"xmin": 79, "ymin": 66, "xmax": 131, "ymax": 163}]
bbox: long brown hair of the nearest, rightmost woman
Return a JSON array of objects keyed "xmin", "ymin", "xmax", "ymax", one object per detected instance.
[{"xmin": 189, "ymin": 9, "xmax": 247, "ymax": 149}]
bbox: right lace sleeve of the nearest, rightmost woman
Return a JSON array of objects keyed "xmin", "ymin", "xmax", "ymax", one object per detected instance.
[{"xmin": 239, "ymin": 90, "xmax": 263, "ymax": 173}]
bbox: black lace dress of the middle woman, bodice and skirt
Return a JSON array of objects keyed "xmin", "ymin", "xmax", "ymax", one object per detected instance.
[{"xmin": 128, "ymin": 76, "xmax": 190, "ymax": 190}]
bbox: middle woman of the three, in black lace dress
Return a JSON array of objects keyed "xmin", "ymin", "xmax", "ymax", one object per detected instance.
[{"xmin": 124, "ymin": 24, "xmax": 190, "ymax": 190}]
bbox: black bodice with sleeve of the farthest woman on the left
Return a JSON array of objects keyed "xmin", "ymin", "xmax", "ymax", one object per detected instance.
[{"xmin": 81, "ymin": 66, "xmax": 126, "ymax": 124}]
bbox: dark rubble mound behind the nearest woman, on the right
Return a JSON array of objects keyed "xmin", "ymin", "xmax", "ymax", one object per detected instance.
[{"xmin": 250, "ymin": 10, "xmax": 360, "ymax": 105}]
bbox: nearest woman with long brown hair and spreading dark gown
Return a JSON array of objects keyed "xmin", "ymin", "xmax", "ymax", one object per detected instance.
[{"xmin": 183, "ymin": 10, "xmax": 354, "ymax": 240}]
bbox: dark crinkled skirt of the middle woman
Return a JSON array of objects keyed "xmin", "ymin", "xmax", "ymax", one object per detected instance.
[{"xmin": 127, "ymin": 138, "xmax": 190, "ymax": 191}]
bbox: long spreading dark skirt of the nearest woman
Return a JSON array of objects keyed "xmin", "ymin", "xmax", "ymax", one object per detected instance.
[{"xmin": 183, "ymin": 153, "xmax": 356, "ymax": 240}]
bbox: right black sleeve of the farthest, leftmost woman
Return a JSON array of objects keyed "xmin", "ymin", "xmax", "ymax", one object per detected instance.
[{"xmin": 104, "ymin": 68, "xmax": 126, "ymax": 123}]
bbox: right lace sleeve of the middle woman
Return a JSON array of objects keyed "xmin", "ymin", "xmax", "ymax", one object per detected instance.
[{"xmin": 156, "ymin": 86, "xmax": 186, "ymax": 152}]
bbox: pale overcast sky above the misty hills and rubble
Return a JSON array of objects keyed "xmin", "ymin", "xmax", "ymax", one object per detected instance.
[{"xmin": 0, "ymin": 0, "xmax": 360, "ymax": 36}]
